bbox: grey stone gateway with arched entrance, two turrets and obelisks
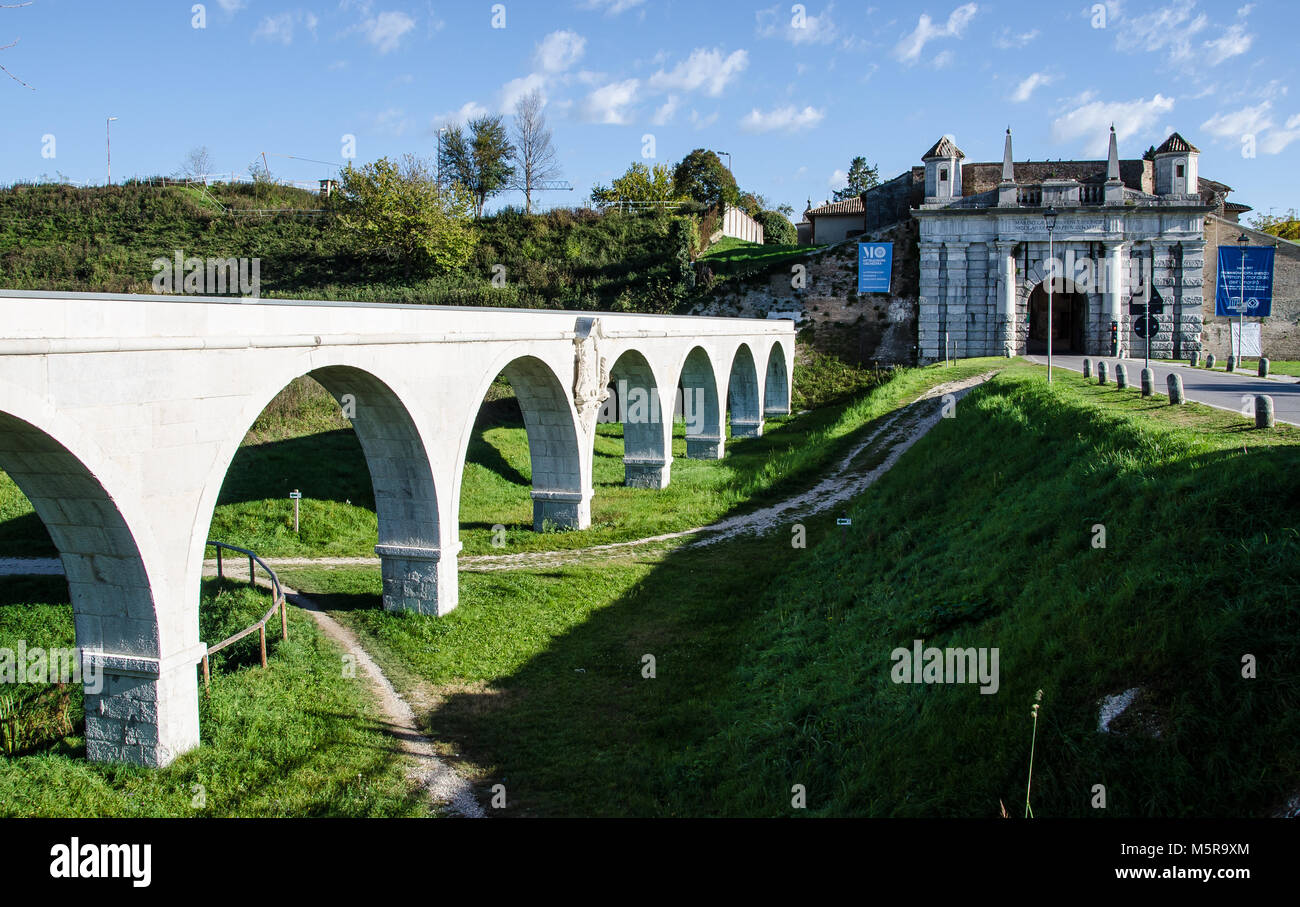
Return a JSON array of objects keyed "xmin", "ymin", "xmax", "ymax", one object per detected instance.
[{"xmin": 915, "ymin": 127, "xmax": 1206, "ymax": 361}]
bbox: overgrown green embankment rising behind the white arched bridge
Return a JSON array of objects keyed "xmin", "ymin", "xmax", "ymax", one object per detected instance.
[{"xmin": 0, "ymin": 183, "xmax": 690, "ymax": 312}]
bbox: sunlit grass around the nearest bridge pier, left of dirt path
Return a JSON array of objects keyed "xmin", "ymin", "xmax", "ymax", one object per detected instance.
[{"xmin": 0, "ymin": 577, "xmax": 428, "ymax": 817}]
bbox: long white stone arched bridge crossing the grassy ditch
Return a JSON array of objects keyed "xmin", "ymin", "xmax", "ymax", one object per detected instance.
[{"xmin": 0, "ymin": 291, "xmax": 794, "ymax": 765}]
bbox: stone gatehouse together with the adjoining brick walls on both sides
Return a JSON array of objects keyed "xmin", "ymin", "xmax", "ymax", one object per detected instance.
[{"xmin": 717, "ymin": 130, "xmax": 1300, "ymax": 364}]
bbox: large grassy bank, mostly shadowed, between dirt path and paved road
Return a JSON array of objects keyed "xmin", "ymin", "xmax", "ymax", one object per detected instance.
[{"xmin": 279, "ymin": 364, "xmax": 1300, "ymax": 817}]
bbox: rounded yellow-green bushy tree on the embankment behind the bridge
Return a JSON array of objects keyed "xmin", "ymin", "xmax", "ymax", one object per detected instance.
[{"xmin": 334, "ymin": 155, "xmax": 476, "ymax": 274}]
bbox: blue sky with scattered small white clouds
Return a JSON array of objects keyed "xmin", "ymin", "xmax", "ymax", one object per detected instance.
[{"xmin": 0, "ymin": 0, "xmax": 1300, "ymax": 220}]
